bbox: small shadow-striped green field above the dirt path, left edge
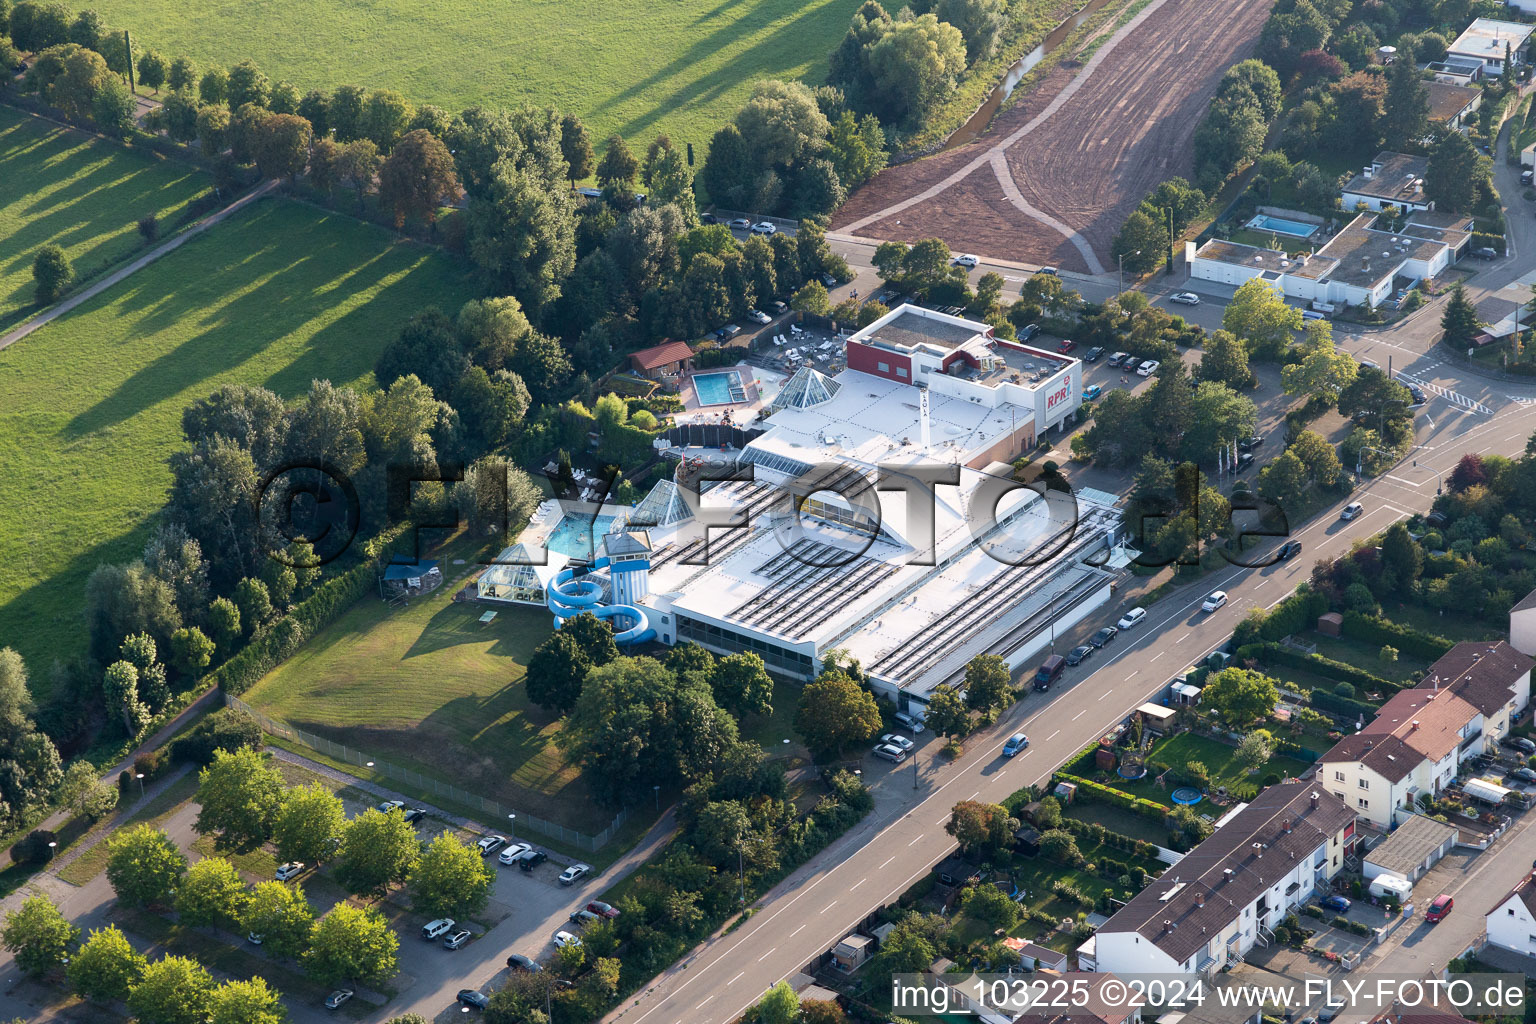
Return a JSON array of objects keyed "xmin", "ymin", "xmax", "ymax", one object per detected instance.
[{"xmin": 0, "ymin": 107, "xmax": 210, "ymax": 330}]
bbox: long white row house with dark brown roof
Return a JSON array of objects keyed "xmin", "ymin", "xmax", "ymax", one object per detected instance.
[{"xmin": 1080, "ymin": 781, "xmax": 1355, "ymax": 976}]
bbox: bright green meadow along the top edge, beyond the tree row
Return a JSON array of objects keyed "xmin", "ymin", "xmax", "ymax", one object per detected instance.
[{"xmin": 81, "ymin": 0, "xmax": 860, "ymax": 158}]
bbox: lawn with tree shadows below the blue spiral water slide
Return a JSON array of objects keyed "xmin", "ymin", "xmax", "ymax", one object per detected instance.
[{"xmin": 243, "ymin": 592, "xmax": 613, "ymax": 832}]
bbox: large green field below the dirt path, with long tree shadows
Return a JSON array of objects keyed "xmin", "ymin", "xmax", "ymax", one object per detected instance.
[{"xmin": 0, "ymin": 200, "xmax": 473, "ymax": 692}]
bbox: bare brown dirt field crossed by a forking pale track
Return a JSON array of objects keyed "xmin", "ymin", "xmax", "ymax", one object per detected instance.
[{"xmin": 833, "ymin": 0, "xmax": 1269, "ymax": 273}]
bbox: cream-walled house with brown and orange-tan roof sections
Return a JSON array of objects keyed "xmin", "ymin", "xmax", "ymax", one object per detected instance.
[{"xmin": 1318, "ymin": 689, "xmax": 1485, "ymax": 831}]
